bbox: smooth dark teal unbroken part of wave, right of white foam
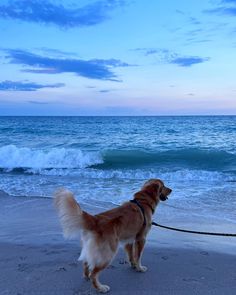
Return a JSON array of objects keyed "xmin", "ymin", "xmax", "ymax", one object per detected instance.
[{"xmin": 93, "ymin": 149, "xmax": 236, "ymax": 170}]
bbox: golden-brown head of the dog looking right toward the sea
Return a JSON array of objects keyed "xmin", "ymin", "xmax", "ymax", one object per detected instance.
[{"xmin": 142, "ymin": 179, "xmax": 172, "ymax": 203}]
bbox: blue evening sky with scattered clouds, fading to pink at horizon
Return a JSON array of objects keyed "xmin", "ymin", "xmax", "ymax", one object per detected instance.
[{"xmin": 0, "ymin": 0, "xmax": 236, "ymax": 116}]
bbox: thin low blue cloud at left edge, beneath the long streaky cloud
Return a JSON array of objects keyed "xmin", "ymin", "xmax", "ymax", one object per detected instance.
[{"xmin": 0, "ymin": 80, "xmax": 64, "ymax": 91}]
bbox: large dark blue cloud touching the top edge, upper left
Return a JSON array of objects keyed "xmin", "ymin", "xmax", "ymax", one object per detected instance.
[{"xmin": 0, "ymin": 0, "xmax": 124, "ymax": 28}]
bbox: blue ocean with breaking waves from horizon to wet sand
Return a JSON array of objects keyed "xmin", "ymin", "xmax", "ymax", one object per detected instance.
[{"xmin": 0, "ymin": 116, "xmax": 236, "ymax": 228}]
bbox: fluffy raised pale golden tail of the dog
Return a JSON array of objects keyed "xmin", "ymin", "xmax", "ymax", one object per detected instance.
[{"xmin": 54, "ymin": 189, "xmax": 96, "ymax": 239}]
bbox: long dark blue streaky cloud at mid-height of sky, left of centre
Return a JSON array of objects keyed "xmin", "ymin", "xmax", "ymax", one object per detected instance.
[{"xmin": 5, "ymin": 49, "xmax": 130, "ymax": 82}]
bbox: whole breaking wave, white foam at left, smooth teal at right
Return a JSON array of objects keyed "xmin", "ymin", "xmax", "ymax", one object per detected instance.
[{"xmin": 0, "ymin": 145, "xmax": 236, "ymax": 173}]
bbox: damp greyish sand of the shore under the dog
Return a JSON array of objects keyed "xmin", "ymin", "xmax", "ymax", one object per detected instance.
[{"xmin": 0, "ymin": 193, "xmax": 236, "ymax": 295}]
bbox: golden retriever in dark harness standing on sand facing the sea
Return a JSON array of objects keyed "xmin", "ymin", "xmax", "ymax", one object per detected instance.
[{"xmin": 55, "ymin": 179, "xmax": 172, "ymax": 293}]
